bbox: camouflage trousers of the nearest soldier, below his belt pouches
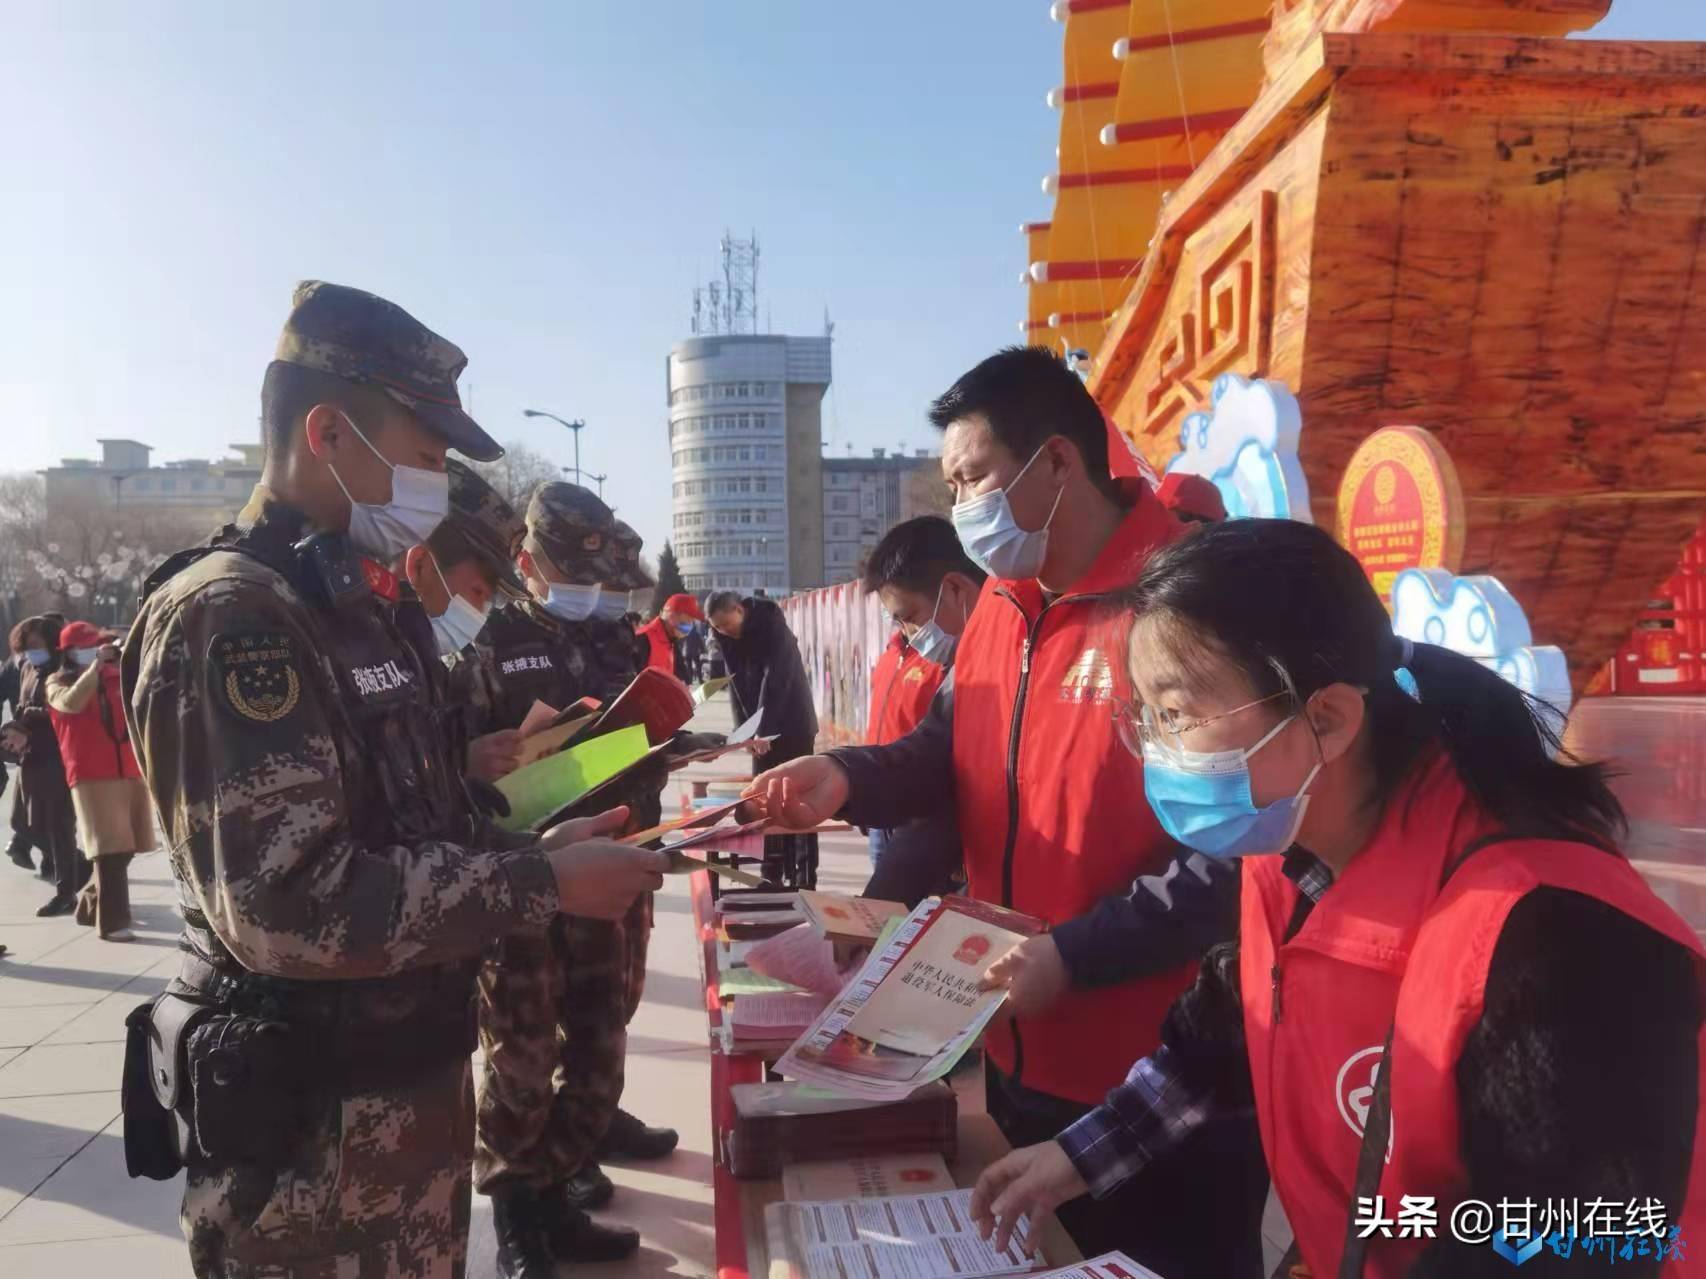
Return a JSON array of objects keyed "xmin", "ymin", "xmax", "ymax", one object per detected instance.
[{"xmin": 183, "ymin": 1061, "xmax": 474, "ymax": 1279}]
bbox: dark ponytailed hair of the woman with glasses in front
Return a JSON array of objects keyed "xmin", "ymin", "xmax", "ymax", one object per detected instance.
[{"xmin": 1128, "ymin": 520, "xmax": 1624, "ymax": 849}]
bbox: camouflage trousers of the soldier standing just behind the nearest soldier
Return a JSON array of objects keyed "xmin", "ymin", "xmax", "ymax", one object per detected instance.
[{"xmin": 474, "ymin": 894, "xmax": 652, "ymax": 1194}]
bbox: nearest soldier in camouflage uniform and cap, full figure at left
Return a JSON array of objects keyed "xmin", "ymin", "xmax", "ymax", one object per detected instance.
[{"xmin": 121, "ymin": 281, "xmax": 662, "ymax": 1279}]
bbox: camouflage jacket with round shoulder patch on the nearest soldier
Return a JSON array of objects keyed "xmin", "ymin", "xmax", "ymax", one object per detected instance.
[{"xmin": 121, "ymin": 488, "xmax": 558, "ymax": 999}]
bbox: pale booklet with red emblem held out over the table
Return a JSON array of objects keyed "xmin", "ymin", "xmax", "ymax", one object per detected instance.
[{"xmin": 776, "ymin": 897, "xmax": 1044, "ymax": 1102}]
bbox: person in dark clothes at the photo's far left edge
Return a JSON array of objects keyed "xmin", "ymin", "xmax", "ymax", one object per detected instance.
[{"xmin": 0, "ymin": 614, "xmax": 90, "ymax": 917}]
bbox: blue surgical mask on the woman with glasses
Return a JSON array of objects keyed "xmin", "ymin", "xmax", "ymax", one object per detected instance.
[{"xmin": 1143, "ymin": 715, "xmax": 1320, "ymax": 858}]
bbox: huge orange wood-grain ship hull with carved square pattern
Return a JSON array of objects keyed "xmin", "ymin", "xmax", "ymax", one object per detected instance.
[{"xmin": 1056, "ymin": 0, "xmax": 1706, "ymax": 689}]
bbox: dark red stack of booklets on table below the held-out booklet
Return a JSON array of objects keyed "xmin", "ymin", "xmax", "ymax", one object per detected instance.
[{"xmin": 727, "ymin": 1084, "xmax": 959, "ymax": 1178}]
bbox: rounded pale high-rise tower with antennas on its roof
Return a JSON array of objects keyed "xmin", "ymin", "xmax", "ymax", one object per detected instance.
[{"xmin": 667, "ymin": 333, "xmax": 831, "ymax": 593}]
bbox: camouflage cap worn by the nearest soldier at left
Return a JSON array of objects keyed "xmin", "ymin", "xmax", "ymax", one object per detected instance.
[{"xmin": 273, "ymin": 280, "xmax": 503, "ymax": 462}]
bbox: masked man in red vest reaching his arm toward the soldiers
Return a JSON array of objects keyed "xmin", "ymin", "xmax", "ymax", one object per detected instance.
[{"xmin": 749, "ymin": 348, "xmax": 1266, "ymax": 1279}]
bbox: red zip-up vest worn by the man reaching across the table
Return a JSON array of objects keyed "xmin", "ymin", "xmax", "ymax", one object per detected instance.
[{"xmin": 954, "ymin": 479, "xmax": 1196, "ymax": 1105}]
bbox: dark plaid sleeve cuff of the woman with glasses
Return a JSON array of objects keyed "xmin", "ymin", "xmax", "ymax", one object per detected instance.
[{"xmin": 1056, "ymin": 1044, "xmax": 1215, "ymax": 1199}]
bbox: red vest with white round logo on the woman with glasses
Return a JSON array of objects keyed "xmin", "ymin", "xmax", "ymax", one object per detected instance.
[{"xmin": 1240, "ymin": 757, "xmax": 1706, "ymax": 1279}]
